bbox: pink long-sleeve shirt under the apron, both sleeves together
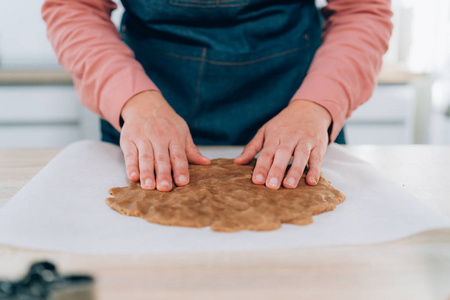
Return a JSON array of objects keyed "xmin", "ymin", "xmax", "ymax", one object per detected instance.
[{"xmin": 42, "ymin": 0, "xmax": 392, "ymax": 141}]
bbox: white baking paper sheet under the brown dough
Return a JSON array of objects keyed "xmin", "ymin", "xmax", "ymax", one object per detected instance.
[{"xmin": 0, "ymin": 141, "xmax": 450, "ymax": 254}]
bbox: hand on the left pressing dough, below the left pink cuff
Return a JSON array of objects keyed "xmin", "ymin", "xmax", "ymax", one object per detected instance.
[{"xmin": 120, "ymin": 91, "xmax": 211, "ymax": 191}]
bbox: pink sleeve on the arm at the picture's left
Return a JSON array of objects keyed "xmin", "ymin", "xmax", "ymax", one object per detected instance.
[{"xmin": 42, "ymin": 0, "xmax": 158, "ymax": 130}]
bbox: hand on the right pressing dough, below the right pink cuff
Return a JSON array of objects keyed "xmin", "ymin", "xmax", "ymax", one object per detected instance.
[{"xmin": 235, "ymin": 100, "xmax": 331, "ymax": 189}]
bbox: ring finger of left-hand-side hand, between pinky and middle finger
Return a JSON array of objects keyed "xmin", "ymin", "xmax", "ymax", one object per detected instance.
[{"xmin": 138, "ymin": 142, "xmax": 156, "ymax": 190}]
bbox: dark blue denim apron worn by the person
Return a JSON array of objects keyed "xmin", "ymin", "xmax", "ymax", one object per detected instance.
[{"xmin": 101, "ymin": 0, "xmax": 344, "ymax": 145}]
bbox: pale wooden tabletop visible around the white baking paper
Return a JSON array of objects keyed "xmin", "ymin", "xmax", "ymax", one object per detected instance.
[{"xmin": 0, "ymin": 145, "xmax": 450, "ymax": 300}]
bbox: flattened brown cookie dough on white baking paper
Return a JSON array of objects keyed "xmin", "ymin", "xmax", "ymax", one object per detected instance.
[{"xmin": 106, "ymin": 159, "xmax": 345, "ymax": 232}]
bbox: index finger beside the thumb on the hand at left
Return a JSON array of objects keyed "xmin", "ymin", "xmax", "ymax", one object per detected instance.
[{"xmin": 169, "ymin": 142, "xmax": 189, "ymax": 186}]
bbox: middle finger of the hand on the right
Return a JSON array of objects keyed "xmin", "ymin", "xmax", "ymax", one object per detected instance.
[{"xmin": 266, "ymin": 144, "xmax": 294, "ymax": 189}]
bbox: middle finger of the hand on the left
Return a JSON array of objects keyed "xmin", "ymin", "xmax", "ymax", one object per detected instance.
[{"xmin": 153, "ymin": 143, "xmax": 172, "ymax": 192}]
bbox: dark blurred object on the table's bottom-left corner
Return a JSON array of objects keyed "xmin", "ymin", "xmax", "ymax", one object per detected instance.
[{"xmin": 0, "ymin": 262, "xmax": 94, "ymax": 300}]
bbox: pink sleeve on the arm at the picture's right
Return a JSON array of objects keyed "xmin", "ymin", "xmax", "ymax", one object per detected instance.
[{"xmin": 292, "ymin": 0, "xmax": 392, "ymax": 141}]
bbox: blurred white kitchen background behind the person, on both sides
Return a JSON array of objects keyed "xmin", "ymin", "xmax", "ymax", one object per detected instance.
[{"xmin": 0, "ymin": 0, "xmax": 450, "ymax": 147}]
